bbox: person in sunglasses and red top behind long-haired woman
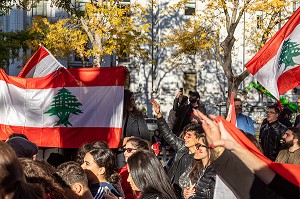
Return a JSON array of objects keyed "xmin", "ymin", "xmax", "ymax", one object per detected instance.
[{"xmin": 119, "ymin": 137, "xmax": 150, "ymax": 199}]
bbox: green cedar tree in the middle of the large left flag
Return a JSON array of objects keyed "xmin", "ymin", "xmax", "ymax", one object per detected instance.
[{"xmin": 45, "ymin": 88, "xmax": 82, "ymax": 127}]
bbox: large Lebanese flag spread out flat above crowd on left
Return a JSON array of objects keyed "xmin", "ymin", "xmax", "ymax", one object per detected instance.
[{"xmin": 0, "ymin": 67, "xmax": 126, "ymax": 148}]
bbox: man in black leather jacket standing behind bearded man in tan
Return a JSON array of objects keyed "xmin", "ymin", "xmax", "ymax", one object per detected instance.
[{"xmin": 259, "ymin": 105, "xmax": 288, "ymax": 161}]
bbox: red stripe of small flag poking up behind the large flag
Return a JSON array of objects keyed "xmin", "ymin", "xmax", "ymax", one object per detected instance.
[{"xmin": 18, "ymin": 46, "xmax": 49, "ymax": 77}]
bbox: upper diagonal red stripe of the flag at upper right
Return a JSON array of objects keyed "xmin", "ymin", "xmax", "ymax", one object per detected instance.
[{"xmin": 245, "ymin": 8, "xmax": 300, "ymax": 75}]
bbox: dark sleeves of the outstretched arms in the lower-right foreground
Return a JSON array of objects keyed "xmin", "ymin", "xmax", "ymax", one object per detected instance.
[{"xmin": 211, "ymin": 150, "xmax": 300, "ymax": 199}]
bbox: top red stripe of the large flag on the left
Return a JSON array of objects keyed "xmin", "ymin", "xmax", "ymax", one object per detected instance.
[{"xmin": 0, "ymin": 66, "xmax": 126, "ymax": 89}]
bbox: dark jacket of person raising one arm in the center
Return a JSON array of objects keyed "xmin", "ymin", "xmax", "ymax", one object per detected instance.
[{"xmin": 157, "ymin": 117, "xmax": 189, "ymax": 183}]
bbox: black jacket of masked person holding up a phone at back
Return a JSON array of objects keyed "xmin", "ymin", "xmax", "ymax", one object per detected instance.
[{"xmin": 169, "ymin": 98, "xmax": 206, "ymax": 135}]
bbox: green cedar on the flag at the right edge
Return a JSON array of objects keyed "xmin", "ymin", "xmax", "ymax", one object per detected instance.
[{"xmin": 278, "ymin": 39, "xmax": 300, "ymax": 72}]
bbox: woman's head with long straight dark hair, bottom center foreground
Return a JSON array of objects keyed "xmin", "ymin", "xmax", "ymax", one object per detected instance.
[{"xmin": 127, "ymin": 150, "xmax": 177, "ymax": 199}]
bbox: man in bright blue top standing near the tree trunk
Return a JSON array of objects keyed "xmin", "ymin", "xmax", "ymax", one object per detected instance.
[{"xmin": 234, "ymin": 98, "xmax": 255, "ymax": 135}]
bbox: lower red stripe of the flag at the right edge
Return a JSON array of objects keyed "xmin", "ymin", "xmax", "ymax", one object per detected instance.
[{"xmin": 277, "ymin": 66, "xmax": 300, "ymax": 95}]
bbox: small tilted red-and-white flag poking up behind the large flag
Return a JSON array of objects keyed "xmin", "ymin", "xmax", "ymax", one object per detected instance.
[{"xmin": 18, "ymin": 45, "xmax": 64, "ymax": 78}]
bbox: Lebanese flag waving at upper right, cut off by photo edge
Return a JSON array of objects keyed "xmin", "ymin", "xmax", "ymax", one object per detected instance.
[{"xmin": 245, "ymin": 8, "xmax": 300, "ymax": 99}]
